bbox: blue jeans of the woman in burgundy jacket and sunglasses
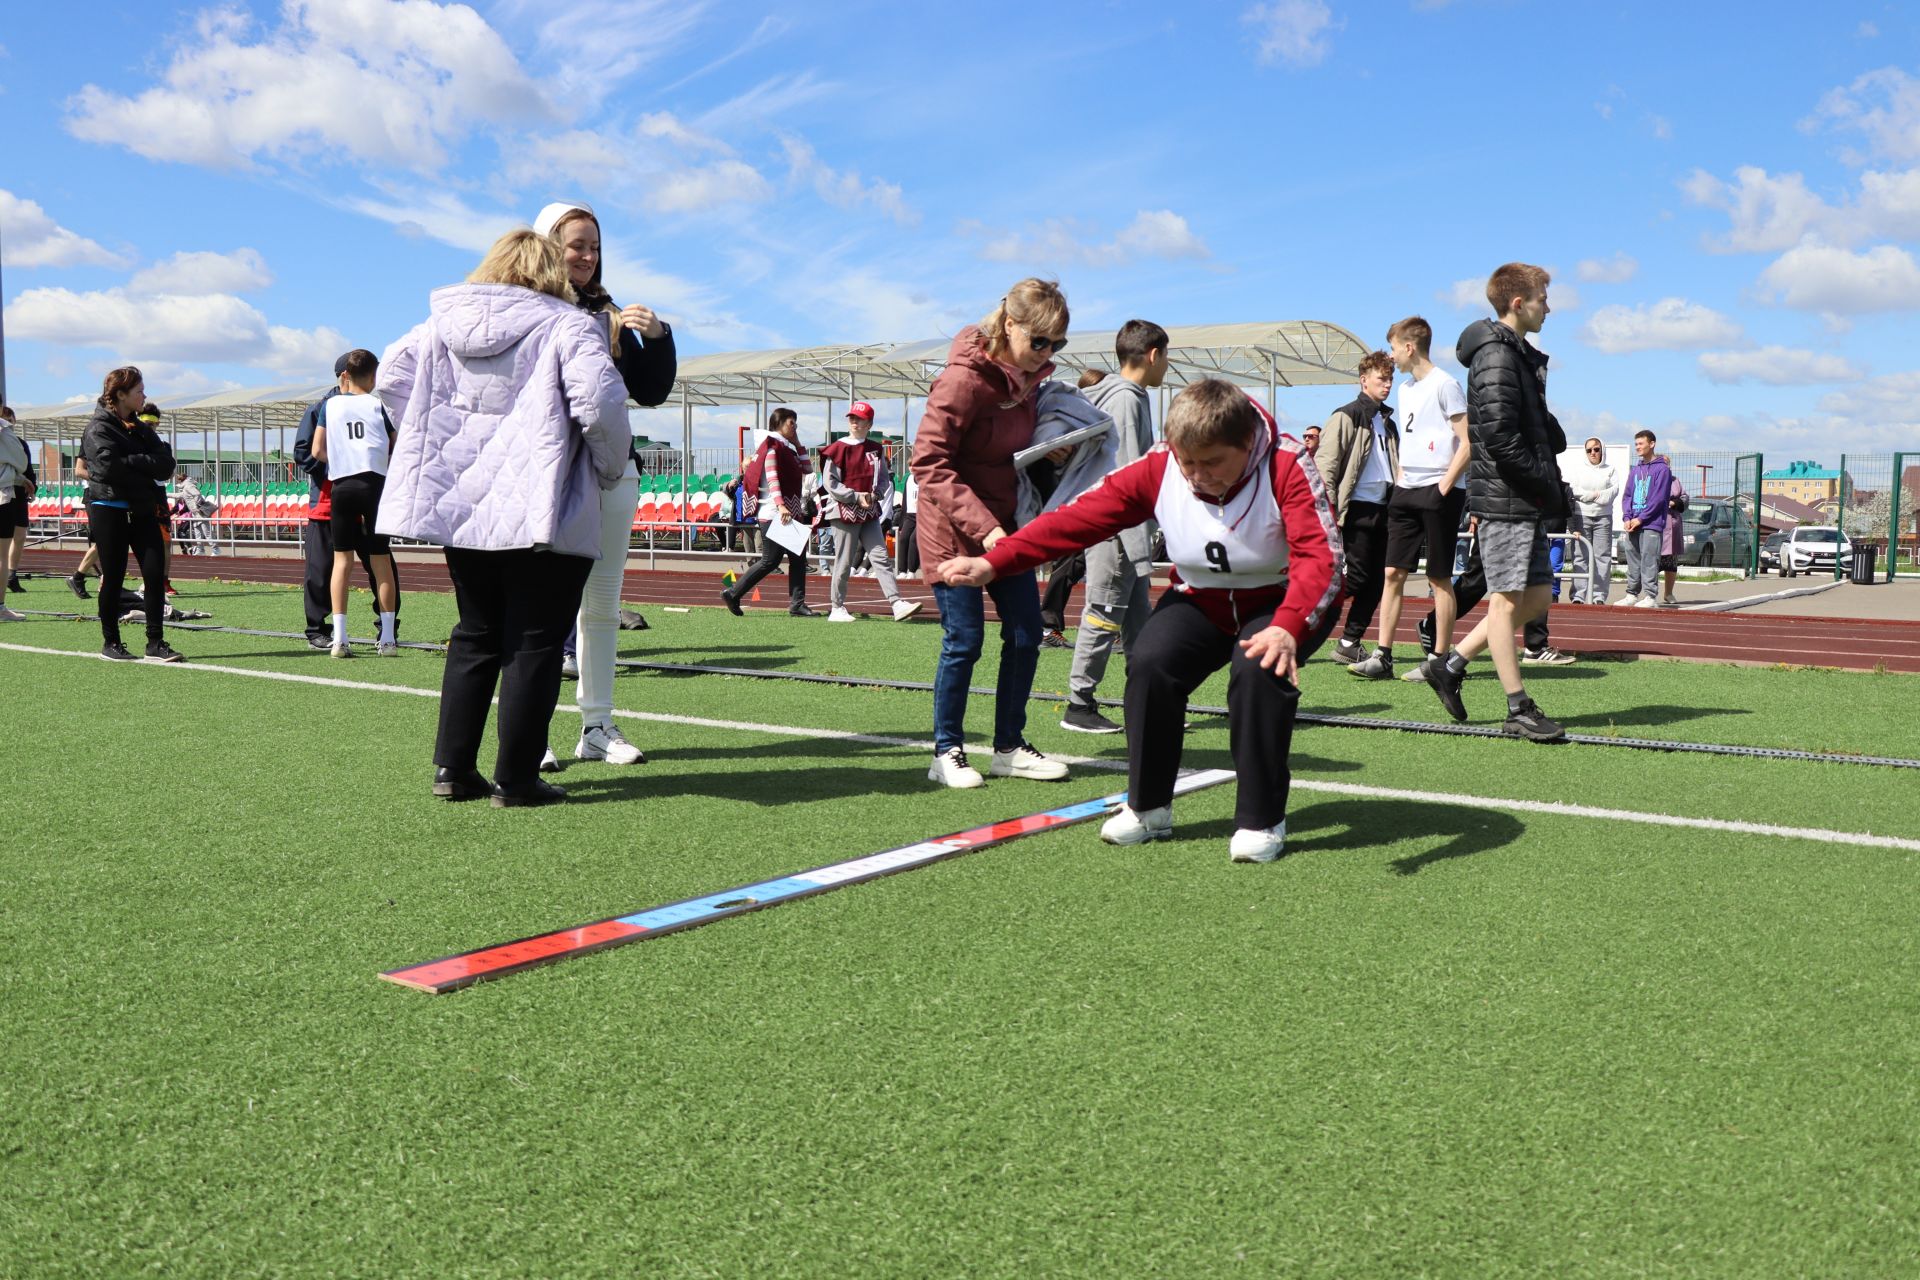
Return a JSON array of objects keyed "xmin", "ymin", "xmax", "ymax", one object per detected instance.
[{"xmin": 933, "ymin": 570, "xmax": 1041, "ymax": 752}]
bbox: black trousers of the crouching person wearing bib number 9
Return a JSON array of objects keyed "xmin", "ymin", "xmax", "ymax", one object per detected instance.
[{"xmin": 1127, "ymin": 591, "xmax": 1332, "ymax": 831}]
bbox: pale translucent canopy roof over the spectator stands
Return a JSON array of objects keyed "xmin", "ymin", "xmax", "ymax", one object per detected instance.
[{"xmin": 7, "ymin": 320, "xmax": 1367, "ymax": 439}]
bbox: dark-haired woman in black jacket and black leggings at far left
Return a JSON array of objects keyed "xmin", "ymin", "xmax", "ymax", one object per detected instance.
[{"xmin": 81, "ymin": 365, "xmax": 182, "ymax": 662}]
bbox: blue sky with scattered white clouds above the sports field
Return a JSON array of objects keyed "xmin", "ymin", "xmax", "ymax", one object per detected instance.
[{"xmin": 0, "ymin": 0, "xmax": 1920, "ymax": 462}]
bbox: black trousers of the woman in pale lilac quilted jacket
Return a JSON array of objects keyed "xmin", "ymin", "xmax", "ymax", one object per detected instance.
[{"xmin": 434, "ymin": 547, "xmax": 593, "ymax": 789}]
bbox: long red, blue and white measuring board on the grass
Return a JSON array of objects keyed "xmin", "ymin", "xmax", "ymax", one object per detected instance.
[{"xmin": 380, "ymin": 770, "xmax": 1233, "ymax": 994}]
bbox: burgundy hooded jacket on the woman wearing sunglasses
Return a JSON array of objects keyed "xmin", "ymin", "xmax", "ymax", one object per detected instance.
[{"xmin": 912, "ymin": 324, "xmax": 1054, "ymax": 566}]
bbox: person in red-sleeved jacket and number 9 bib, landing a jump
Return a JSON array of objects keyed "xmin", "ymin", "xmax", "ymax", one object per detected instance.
[{"xmin": 937, "ymin": 380, "xmax": 1340, "ymax": 862}]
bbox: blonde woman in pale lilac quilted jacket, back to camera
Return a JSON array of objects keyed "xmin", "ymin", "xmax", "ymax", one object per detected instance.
[{"xmin": 374, "ymin": 230, "xmax": 630, "ymax": 808}]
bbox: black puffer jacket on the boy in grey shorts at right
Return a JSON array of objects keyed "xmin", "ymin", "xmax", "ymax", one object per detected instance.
[{"xmin": 1455, "ymin": 320, "xmax": 1567, "ymax": 520}]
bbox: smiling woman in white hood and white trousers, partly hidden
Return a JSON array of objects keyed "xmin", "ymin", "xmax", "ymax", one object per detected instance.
[{"xmin": 534, "ymin": 201, "xmax": 680, "ymax": 771}]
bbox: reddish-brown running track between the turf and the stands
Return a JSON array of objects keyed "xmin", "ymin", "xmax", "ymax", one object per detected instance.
[{"xmin": 13, "ymin": 551, "xmax": 1920, "ymax": 672}]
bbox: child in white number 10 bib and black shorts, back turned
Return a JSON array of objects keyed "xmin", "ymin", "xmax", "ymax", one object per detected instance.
[{"xmin": 313, "ymin": 349, "xmax": 399, "ymax": 658}]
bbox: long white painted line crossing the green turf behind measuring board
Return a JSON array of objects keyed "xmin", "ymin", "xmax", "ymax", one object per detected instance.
[{"xmin": 11, "ymin": 645, "xmax": 1920, "ymax": 852}]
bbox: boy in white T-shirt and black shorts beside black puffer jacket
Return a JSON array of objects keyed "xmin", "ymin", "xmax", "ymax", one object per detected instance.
[{"xmin": 1346, "ymin": 315, "xmax": 1471, "ymax": 679}]
